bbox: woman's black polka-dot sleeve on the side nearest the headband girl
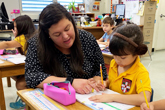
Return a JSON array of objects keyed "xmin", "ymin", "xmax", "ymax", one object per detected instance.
[{"xmin": 80, "ymin": 30, "xmax": 107, "ymax": 80}]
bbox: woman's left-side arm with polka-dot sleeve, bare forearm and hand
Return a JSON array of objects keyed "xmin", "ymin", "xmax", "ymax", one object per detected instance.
[{"xmin": 25, "ymin": 38, "xmax": 97, "ymax": 94}]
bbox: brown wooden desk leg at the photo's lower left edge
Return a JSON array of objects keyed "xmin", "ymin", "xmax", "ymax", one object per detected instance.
[{"xmin": 0, "ymin": 76, "xmax": 6, "ymax": 110}]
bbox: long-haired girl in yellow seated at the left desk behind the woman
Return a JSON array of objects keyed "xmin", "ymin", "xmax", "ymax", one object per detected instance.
[{"xmin": 0, "ymin": 15, "xmax": 35, "ymax": 108}]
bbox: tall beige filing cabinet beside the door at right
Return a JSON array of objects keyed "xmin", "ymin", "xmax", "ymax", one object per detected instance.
[{"xmin": 140, "ymin": 1, "xmax": 157, "ymax": 55}]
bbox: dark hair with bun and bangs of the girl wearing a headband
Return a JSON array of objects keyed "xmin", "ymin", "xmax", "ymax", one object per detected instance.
[{"xmin": 109, "ymin": 22, "xmax": 147, "ymax": 56}]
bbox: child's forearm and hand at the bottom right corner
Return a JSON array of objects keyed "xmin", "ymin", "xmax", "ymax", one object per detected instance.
[{"xmin": 140, "ymin": 99, "xmax": 165, "ymax": 110}]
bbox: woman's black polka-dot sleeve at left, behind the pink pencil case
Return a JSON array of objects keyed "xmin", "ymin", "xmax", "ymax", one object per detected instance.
[{"xmin": 25, "ymin": 37, "xmax": 50, "ymax": 88}]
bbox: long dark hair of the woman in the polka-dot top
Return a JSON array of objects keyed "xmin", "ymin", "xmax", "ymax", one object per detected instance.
[{"xmin": 38, "ymin": 3, "xmax": 85, "ymax": 77}]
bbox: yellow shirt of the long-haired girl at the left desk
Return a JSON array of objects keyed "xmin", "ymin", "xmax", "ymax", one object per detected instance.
[{"xmin": 14, "ymin": 34, "xmax": 26, "ymax": 53}]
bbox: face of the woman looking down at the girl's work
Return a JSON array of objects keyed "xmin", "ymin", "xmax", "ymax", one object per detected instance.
[{"xmin": 49, "ymin": 18, "xmax": 75, "ymax": 54}]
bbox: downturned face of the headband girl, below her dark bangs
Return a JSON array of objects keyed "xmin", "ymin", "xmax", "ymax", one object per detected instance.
[{"xmin": 113, "ymin": 54, "xmax": 137, "ymax": 67}]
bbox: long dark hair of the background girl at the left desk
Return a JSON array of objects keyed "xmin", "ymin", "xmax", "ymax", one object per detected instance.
[{"xmin": 14, "ymin": 15, "xmax": 35, "ymax": 55}]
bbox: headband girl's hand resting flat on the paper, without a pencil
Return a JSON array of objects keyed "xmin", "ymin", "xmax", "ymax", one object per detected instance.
[{"xmin": 89, "ymin": 93, "xmax": 116, "ymax": 102}]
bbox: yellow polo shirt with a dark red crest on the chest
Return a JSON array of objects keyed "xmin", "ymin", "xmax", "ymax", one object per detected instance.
[{"xmin": 109, "ymin": 57, "xmax": 151, "ymax": 94}]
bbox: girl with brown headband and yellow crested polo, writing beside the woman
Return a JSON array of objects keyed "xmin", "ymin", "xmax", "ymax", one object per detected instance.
[{"xmin": 89, "ymin": 23, "xmax": 151, "ymax": 106}]
